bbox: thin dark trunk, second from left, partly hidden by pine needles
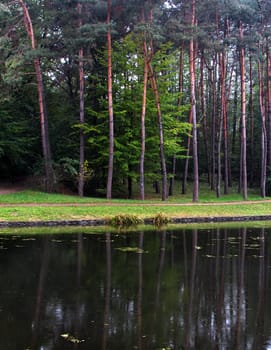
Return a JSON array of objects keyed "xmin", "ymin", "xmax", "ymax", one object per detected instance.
[{"xmin": 77, "ymin": 3, "xmax": 85, "ymax": 197}]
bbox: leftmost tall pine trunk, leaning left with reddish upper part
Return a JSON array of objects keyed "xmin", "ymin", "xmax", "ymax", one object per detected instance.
[{"xmin": 18, "ymin": 0, "xmax": 55, "ymax": 192}]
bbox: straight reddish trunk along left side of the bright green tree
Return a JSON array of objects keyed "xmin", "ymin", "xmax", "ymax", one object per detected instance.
[{"xmin": 106, "ymin": 0, "xmax": 114, "ymax": 199}]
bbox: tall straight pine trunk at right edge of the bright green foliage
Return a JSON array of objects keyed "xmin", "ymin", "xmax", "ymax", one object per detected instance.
[{"xmin": 189, "ymin": 0, "xmax": 199, "ymax": 202}]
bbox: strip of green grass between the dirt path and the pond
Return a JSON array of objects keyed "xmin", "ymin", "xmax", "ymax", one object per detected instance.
[{"xmin": 0, "ymin": 202, "xmax": 271, "ymax": 221}]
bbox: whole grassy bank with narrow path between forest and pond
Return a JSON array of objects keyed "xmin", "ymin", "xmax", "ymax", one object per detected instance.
[{"xmin": 0, "ymin": 191, "xmax": 271, "ymax": 221}]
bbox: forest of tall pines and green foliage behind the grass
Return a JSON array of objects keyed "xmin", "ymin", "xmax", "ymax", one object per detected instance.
[{"xmin": 0, "ymin": 0, "xmax": 271, "ymax": 202}]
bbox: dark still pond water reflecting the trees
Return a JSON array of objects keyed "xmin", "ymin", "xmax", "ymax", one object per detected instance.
[{"xmin": 0, "ymin": 228, "xmax": 271, "ymax": 350}]
